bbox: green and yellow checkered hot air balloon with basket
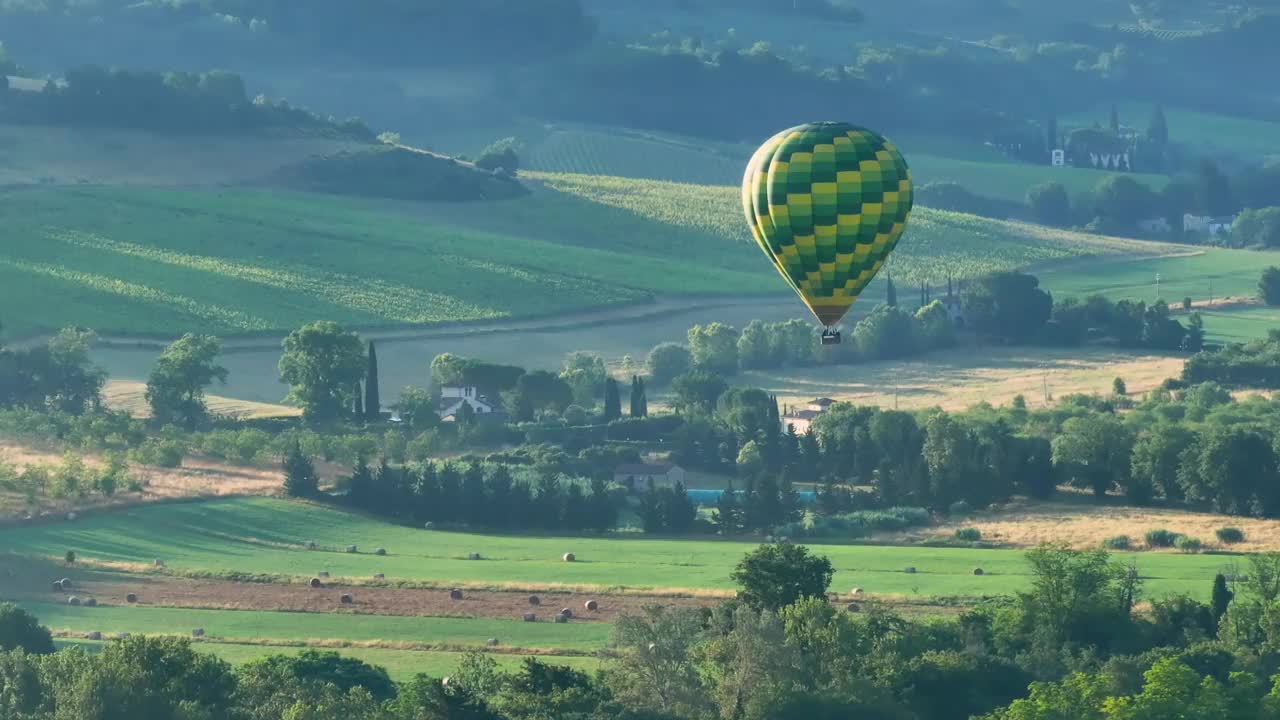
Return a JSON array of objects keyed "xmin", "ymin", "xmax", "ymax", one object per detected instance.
[{"xmin": 742, "ymin": 123, "xmax": 913, "ymax": 345}]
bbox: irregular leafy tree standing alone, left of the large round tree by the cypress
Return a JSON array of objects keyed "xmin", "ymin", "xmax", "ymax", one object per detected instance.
[{"xmin": 146, "ymin": 333, "xmax": 227, "ymax": 430}]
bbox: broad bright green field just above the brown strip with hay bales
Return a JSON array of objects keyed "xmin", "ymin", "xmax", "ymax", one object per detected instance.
[{"xmin": 0, "ymin": 498, "xmax": 1238, "ymax": 599}]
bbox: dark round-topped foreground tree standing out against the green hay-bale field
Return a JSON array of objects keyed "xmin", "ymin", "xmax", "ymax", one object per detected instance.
[{"xmin": 731, "ymin": 543, "xmax": 835, "ymax": 611}]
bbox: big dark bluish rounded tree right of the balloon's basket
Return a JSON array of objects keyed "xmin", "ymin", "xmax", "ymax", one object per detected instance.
[{"xmin": 960, "ymin": 272, "xmax": 1053, "ymax": 342}]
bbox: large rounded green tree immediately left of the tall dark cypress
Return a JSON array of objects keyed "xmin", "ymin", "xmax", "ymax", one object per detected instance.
[{"xmin": 280, "ymin": 320, "xmax": 366, "ymax": 421}]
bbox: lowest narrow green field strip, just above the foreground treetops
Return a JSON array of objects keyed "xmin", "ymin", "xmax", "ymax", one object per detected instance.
[{"xmin": 55, "ymin": 638, "xmax": 602, "ymax": 683}]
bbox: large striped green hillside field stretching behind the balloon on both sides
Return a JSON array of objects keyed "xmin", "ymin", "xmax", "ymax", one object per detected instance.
[{"xmin": 0, "ymin": 174, "xmax": 1165, "ymax": 338}]
